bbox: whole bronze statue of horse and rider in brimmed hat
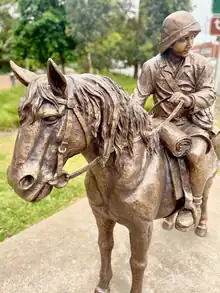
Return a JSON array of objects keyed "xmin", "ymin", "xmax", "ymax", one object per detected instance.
[{"xmin": 8, "ymin": 12, "xmax": 218, "ymax": 293}]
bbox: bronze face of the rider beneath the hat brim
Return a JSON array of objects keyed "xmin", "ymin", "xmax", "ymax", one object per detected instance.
[{"xmin": 171, "ymin": 33, "xmax": 195, "ymax": 57}]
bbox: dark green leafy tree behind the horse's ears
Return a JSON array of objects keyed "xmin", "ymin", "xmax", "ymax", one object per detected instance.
[{"xmin": 13, "ymin": 0, "xmax": 76, "ymax": 72}]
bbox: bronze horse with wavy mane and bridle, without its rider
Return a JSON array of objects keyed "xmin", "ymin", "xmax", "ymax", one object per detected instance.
[{"xmin": 7, "ymin": 59, "xmax": 218, "ymax": 293}]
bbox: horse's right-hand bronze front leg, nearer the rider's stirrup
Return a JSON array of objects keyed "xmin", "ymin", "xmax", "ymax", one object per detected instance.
[{"xmin": 130, "ymin": 222, "xmax": 153, "ymax": 293}]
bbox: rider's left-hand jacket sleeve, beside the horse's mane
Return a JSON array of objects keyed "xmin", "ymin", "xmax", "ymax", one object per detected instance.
[{"xmin": 131, "ymin": 61, "xmax": 154, "ymax": 107}]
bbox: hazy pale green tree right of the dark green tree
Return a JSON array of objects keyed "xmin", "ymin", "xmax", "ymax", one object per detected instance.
[{"xmin": 66, "ymin": 0, "xmax": 132, "ymax": 72}]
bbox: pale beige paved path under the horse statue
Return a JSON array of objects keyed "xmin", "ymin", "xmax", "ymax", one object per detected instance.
[{"xmin": 0, "ymin": 178, "xmax": 220, "ymax": 293}]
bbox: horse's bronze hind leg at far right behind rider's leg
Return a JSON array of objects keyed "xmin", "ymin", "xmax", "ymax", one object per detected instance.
[{"xmin": 195, "ymin": 179, "xmax": 213, "ymax": 237}]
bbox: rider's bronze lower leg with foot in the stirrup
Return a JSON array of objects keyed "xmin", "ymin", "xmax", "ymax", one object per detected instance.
[{"xmin": 176, "ymin": 137, "xmax": 207, "ymax": 231}]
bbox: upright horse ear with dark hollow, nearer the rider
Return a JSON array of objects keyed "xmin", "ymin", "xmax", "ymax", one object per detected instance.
[{"xmin": 47, "ymin": 58, "xmax": 67, "ymax": 94}]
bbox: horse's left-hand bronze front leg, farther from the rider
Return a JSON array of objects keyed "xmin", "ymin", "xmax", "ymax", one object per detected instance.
[{"xmin": 94, "ymin": 213, "xmax": 115, "ymax": 293}]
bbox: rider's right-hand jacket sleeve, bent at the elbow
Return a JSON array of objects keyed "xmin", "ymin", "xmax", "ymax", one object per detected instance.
[{"xmin": 190, "ymin": 58, "xmax": 216, "ymax": 112}]
